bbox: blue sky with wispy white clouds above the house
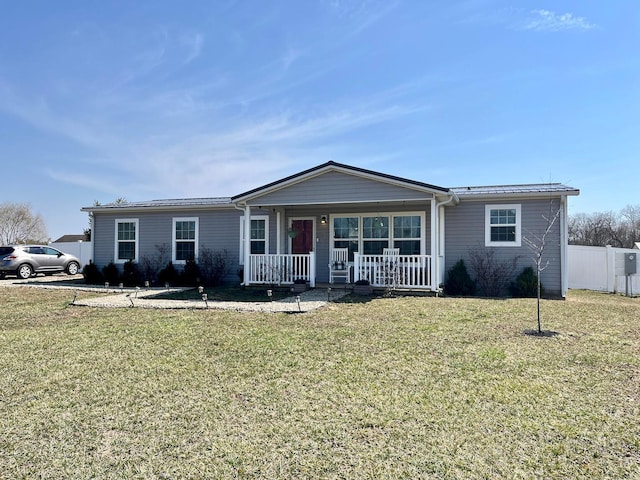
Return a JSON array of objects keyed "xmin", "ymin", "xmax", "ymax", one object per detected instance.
[{"xmin": 0, "ymin": 0, "xmax": 640, "ymax": 239}]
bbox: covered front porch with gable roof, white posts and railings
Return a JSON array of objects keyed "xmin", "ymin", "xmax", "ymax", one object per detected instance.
[{"xmin": 232, "ymin": 162, "xmax": 455, "ymax": 291}]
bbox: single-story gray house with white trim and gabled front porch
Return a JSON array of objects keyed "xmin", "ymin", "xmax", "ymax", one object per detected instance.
[{"xmin": 82, "ymin": 161, "xmax": 579, "ymax": 295}]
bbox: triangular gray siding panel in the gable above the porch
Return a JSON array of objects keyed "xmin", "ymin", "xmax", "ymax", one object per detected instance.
[{"xmin": 250, "ymin": 172, "xmax": 432, "ymax": 205}]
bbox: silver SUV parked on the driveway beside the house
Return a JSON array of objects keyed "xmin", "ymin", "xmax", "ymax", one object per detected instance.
[{"xmin": 0, "ymin": 245, "xmax": 80, "ymax": 279}]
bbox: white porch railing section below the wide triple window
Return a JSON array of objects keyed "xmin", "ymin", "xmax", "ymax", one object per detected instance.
[{"xmin": 353, "ymin": 253, "xmax": 432, "ymax": 288}]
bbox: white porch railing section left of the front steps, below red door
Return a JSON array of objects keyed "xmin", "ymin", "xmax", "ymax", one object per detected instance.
[{"xmin": 249, "ymin": 252, "xmax": 316, "ymax": 287}]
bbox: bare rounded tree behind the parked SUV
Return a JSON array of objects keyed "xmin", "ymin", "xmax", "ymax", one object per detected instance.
[{"xmin": 0, "ymin": 203, "xmax": 47, "ymax": 245}]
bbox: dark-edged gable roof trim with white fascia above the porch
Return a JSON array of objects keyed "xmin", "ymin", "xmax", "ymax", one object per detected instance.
[{"xmin": 231, "ymin": 161, "xmax": 449, "ymax": 202}]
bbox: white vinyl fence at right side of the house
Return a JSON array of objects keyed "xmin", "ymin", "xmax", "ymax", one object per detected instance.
[{"xmin": 567, "ymin": 245, "xmax": 640, "ymax": 295}]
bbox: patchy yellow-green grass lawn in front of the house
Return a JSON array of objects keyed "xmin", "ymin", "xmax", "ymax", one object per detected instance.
[{"xmin": 0, "ymin": 288, "xmax": 640, "ymax": 479}]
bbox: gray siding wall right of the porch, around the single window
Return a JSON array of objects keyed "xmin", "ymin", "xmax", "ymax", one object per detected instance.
[{"xmin": 445, "ymin": 199, "xmax": 562, "ymax": 295}]
